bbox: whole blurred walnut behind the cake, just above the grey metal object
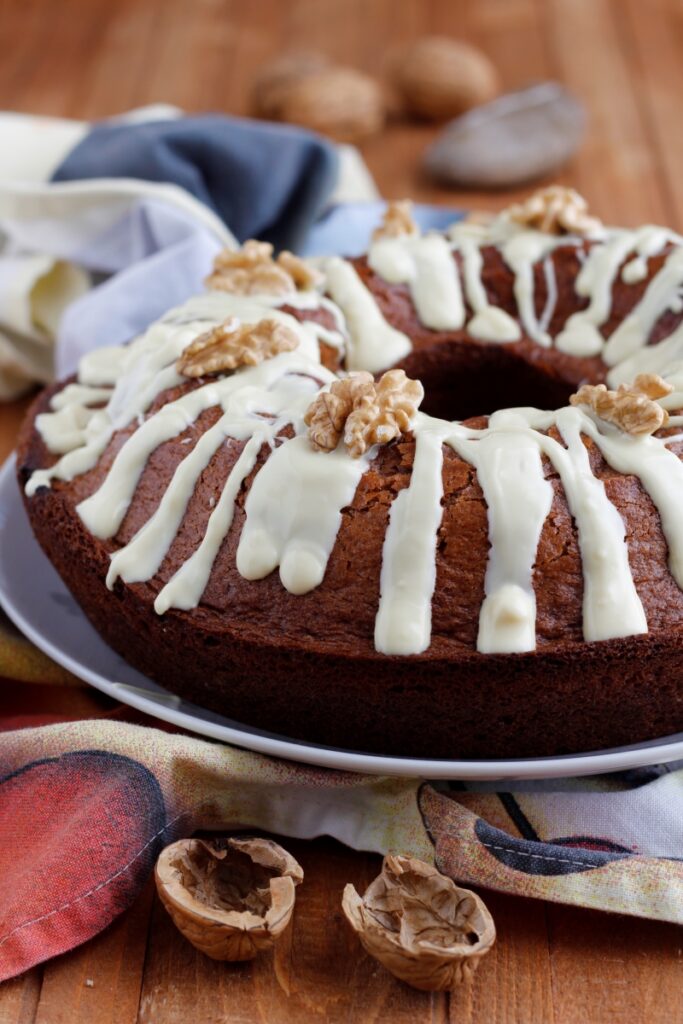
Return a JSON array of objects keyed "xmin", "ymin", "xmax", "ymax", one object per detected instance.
[{"xmin": 392, "ymin": 36, "xmax": 500, "ymax": 121}]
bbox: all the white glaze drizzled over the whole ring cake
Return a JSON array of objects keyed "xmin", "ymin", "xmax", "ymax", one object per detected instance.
[{"xmin": 27, "ymin": 223, "xmax": 683, "ymax": 655}]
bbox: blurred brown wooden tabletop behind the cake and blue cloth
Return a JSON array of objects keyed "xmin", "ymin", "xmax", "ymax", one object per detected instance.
[{"xmin": 0, "ymin": 0, "xmax": 683, "ymax": 228}]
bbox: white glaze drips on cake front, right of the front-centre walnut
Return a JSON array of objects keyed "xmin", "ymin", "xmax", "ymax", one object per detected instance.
[{"xmin": 376, "ymin": 391, "xmax": 683, "ymax": 654}]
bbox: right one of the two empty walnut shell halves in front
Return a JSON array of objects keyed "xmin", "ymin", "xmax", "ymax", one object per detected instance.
[{"xmin": 342, "ymin": 856, "xmax": 496, "ymax": 991}]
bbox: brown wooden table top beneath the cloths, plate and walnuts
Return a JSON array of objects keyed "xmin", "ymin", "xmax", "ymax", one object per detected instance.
[{"xmin": 0, "ymin": 0, "xmax": 683, "ymax": 1024}]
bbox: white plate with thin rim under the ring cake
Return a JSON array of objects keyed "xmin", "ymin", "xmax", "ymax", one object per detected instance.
[{"xmin": 0, "ymin": 457, "xmax": 683, "ymax": 779}]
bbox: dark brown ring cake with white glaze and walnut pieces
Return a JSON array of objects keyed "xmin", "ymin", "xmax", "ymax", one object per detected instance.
[{"xmin": 17, "ymin": 188, "xmax": 683, "ymax": 758}]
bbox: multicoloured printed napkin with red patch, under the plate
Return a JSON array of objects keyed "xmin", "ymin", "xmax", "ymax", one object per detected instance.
[{"xmin": 0, "ymin": 606, "xmax": 683, "ymax": 980}]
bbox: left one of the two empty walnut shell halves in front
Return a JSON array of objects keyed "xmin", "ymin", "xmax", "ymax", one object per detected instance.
[{"xmin": 155, "ymin": 839, "xmax": 303, "ymax": 961}]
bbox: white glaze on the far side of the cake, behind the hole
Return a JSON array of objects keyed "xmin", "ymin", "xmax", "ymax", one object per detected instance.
[{"xmin": 362, "ymin": 215, "xmax": 683, "ymax": 379}]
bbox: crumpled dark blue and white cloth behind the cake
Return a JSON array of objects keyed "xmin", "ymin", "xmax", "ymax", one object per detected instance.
[{"xmin": 0, "ymin": 106, "xmax": 377, "ymax": 400}]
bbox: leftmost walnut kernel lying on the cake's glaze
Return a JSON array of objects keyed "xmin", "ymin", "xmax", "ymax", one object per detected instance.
[{"xmin": 176, "ymin": 319, "xmax": 299, "ymax": 377}]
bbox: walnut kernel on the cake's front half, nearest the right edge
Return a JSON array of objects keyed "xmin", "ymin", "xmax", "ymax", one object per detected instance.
[{"xmin": 569, "ymin": 374, "xmax": 673, "ymax": 436}]
